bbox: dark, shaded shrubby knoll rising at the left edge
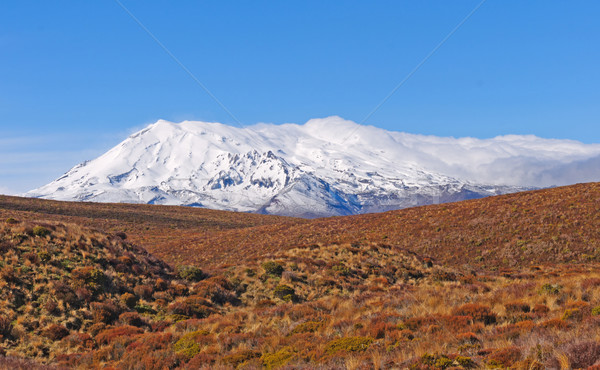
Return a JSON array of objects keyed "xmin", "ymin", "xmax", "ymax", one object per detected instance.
[{"xmin": 0, "ymin": 222, "xmax": 180, "ymax": 363}]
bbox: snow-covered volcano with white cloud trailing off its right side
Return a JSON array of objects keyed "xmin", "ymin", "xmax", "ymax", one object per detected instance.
[{"xmin": 27, "ymin": 117, "xmax": 600, "ymax": 217}]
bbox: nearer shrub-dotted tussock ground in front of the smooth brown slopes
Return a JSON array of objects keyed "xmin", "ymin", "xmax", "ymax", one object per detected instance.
[{"xmin": 0, "ymin": 205, "xmax": 600, "ymax": 369}]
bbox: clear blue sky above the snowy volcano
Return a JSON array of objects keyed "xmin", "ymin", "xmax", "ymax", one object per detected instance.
[{"xmin": 0, "ymin": 0, "xmax": 600, "ymax": 193}]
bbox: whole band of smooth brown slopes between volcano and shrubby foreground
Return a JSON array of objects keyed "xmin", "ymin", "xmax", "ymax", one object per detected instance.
[{"xmin": 0, "ymin": 183, "xmax": 600, "ymax": 269}]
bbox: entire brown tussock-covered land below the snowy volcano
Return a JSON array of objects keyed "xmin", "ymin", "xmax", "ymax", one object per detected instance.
[{"xmin": 0, "ymin": 183, "xmax": 600, "ymax": 369}]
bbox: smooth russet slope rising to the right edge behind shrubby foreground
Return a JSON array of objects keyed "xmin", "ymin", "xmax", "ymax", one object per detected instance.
[{"xmin": 186, "ymin": 183, "xmax": 600, "ymax": 268}]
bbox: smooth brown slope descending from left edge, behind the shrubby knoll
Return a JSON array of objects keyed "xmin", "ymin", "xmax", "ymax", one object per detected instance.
[{"xmin": 0, "ymin": 195, "xmax": 306, "ymax": 268}]
